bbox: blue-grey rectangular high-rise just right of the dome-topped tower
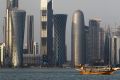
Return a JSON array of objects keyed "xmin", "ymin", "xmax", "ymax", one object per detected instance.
[{"xmin": 88, "ymin": 18, "xmax": 100, "ymax": 64}]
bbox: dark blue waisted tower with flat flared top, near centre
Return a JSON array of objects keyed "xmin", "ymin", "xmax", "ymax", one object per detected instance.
[{"xmin": 54, "ymin": 14, "xmax": 67, "ymax": 66}]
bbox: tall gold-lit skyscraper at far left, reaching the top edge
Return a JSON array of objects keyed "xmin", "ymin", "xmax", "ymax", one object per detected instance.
[{"xmin": 4, "ymin": 0, "xmax": 18, "ymax": 66}]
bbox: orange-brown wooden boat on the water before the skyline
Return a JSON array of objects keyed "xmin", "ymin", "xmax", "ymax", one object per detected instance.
[{"xmin": 79, "ymin": 67, "xmax": 115, "ymax": 75}]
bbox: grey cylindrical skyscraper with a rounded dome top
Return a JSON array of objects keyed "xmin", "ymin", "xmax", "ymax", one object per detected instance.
[{"xmin": 71, "ymin": 10, "xmax": 85, "ymax": 66}]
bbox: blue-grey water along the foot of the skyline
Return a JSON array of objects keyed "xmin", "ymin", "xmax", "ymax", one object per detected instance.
[{"xmin": 0, "ymin": 68, "xmax": 120, "ymax": 80}]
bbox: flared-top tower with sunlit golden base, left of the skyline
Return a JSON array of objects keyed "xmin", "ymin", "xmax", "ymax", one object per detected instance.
[{"xmin": 11, "ymin": 9, "xmax": 26, "ymax": 67}]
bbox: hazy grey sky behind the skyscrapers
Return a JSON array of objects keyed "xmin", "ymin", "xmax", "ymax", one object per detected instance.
[{"xmin": 0, "ymin": 0, "xmax": 120, "ymax": 59}]
